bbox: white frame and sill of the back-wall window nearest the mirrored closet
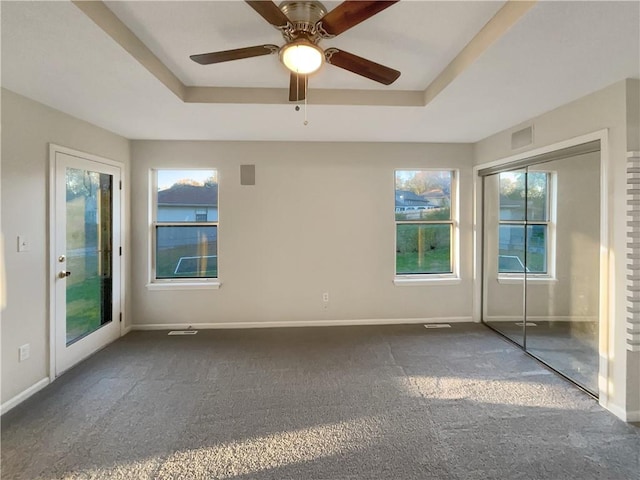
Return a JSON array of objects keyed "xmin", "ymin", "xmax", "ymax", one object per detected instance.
[{"xmin": 390, "ymin": 167, "xmax": 461, "ymax": 286}]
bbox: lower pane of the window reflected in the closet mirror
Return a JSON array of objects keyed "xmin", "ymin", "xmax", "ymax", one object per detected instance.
[{"xmin": 498, "ymin": 225, "xmax": 547, "ymax": 273}]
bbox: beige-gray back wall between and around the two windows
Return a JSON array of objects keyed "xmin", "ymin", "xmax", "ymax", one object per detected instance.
[{"xmin": 132, "ymin": 141, "xmax": 472, "ymax": 325}]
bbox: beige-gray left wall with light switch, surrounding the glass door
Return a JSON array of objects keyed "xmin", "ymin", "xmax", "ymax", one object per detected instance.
[{"xmin": 1, "ymin": 89, "xmax": 130, "ymax": 403}]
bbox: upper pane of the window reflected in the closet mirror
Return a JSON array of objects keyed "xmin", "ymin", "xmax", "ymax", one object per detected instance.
[{"xmin": 500, "ymin": 172, "xmax": 549, "ymax": 222}]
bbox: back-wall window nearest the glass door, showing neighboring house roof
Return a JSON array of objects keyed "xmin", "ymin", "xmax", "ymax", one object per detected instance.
[{"xmin": 153, "ymin": 170, "xmax": 218, "ymax": 281}]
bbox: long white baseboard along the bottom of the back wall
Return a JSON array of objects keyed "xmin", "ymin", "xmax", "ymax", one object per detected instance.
[{"xmin": 130, "ymin": 316, "xmax": 473, "ymax": 330}]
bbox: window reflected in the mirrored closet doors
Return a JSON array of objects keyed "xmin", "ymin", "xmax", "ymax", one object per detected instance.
[{"xmin": 498, "ymin": 172, "xmax": 552, "ymax": 276}]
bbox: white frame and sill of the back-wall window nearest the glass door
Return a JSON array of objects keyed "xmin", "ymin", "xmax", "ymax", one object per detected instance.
[{"xmin": 146, "ymin": 167, "xmax": 222, "ymax": 290}]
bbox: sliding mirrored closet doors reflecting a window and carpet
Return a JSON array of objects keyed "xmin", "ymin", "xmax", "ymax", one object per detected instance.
[{"xmin": 481, "ymin": 142, "xmax": 600, "ymax": 395}]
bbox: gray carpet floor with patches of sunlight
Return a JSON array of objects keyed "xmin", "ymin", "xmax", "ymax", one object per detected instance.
[{"xmin": 1, "ymin": 324, "xmax": 640, "ymax": 480}]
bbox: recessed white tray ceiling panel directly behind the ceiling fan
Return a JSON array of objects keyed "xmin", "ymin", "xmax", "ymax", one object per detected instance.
[{"xmin": 107, "ymin": 1, "xmax": 504, "ymax": 90}]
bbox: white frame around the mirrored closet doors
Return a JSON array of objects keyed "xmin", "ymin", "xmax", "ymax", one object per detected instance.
[{"xmin": 472, "ymin": 129, "xmax": 615, "ymax": 409}]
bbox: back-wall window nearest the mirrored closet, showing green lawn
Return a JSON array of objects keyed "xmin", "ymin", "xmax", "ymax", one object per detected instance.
[{"xmin": 395, "ymin": 170, "xmax": 455, "ymax": 275}]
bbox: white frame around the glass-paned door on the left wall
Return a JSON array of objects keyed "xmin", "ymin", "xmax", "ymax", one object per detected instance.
[{"xmin": 47, "ymin": 143, "xmax": 127, "ymax": 382}]
